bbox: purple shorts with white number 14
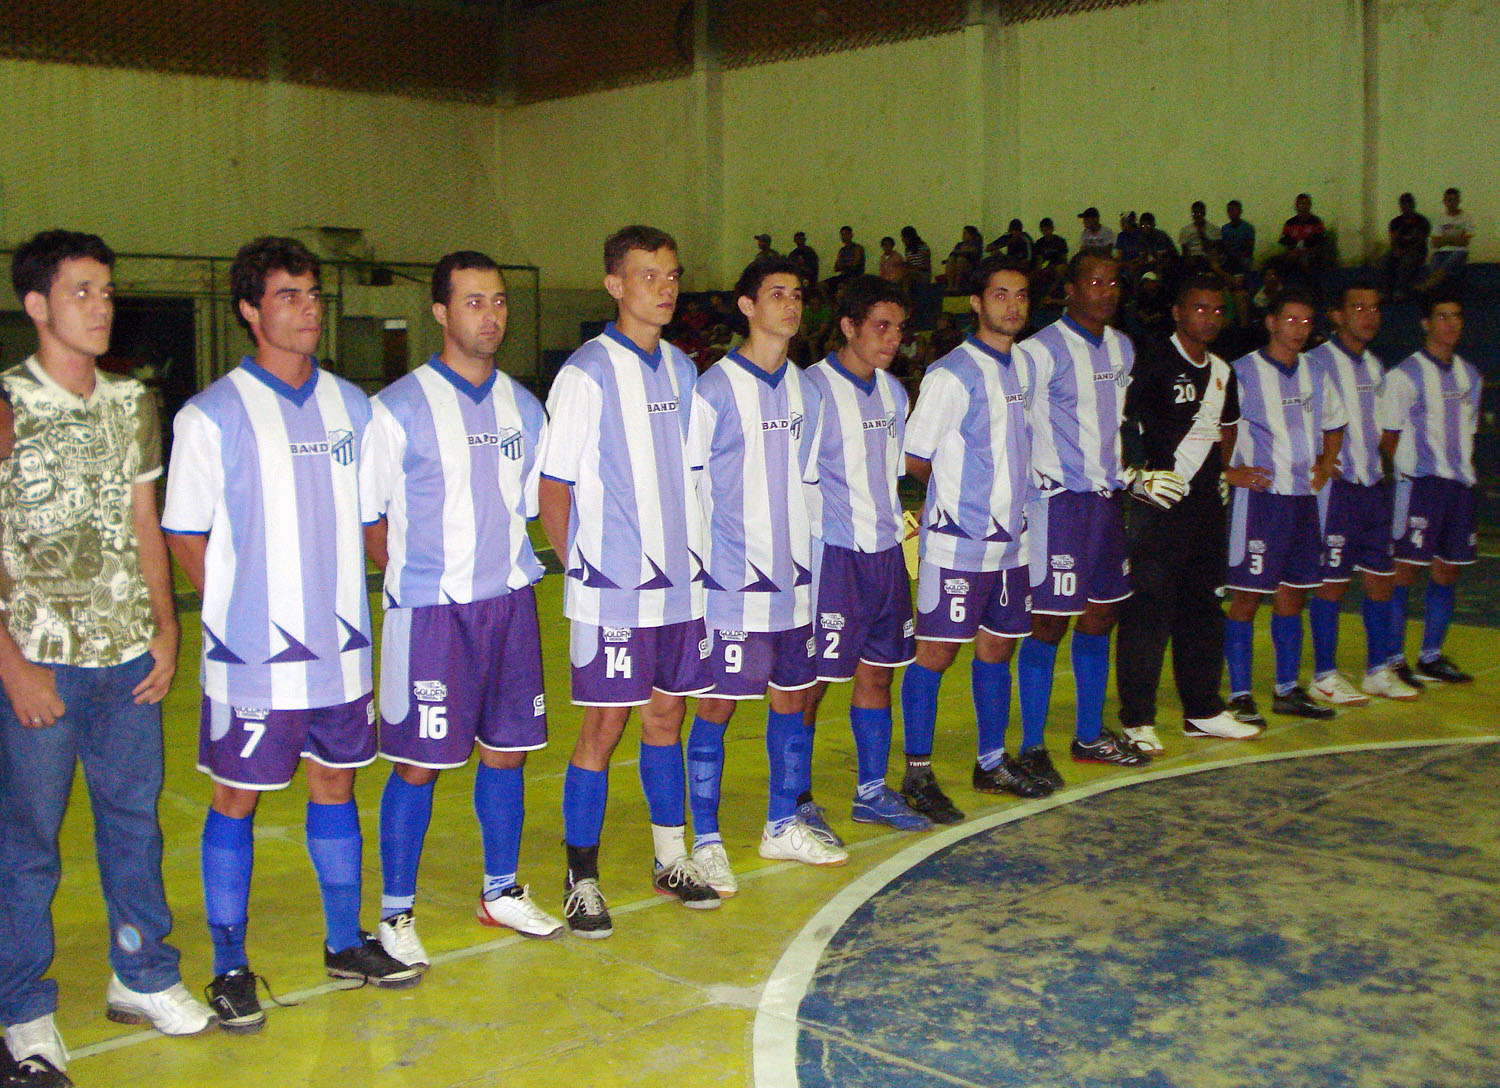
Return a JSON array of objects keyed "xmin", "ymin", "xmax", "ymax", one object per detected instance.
[{"xmin": 572, "ymin": 620, "xmax": 714, "ymax": 707}]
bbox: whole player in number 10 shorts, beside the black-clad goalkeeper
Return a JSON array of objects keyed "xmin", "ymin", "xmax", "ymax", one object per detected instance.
[{"xmin": 1014, "ymin": 249, "xmax": 1151, "ymax": 789}]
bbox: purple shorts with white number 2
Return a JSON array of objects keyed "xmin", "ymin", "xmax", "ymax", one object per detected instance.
[{"xmin": 818, "ymin": 545, "xmax": 917, "ymax": 680}]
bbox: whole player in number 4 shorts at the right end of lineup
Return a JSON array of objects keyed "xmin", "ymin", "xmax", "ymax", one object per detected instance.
[{"xmin": 1380, "ymin": 296, "xmax": 1481, "ymax": 684}]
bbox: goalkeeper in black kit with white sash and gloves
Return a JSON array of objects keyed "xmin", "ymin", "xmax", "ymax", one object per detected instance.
[{"xmin": 1115, "ymin": 276, "xmax": 1260, "ymax": 755}]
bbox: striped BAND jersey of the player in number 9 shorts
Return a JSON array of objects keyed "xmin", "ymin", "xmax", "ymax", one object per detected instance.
[{"xmin": 689, "ymin": 351, "xmax": 818, "ymax": 630}]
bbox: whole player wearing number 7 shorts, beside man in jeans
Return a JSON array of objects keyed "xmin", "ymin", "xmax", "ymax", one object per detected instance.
[{"xmin": 162, "ymin": 237, "xmax": 422, "ymax": 1032}]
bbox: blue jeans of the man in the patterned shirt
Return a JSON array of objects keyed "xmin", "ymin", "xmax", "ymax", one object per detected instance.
[{"xmin": 0, "ymin": 654, "xmax": 182, "ymax": 1025}]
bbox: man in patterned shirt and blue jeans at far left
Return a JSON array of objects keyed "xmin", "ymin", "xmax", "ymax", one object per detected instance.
[{"xmin": 0, "ymin": 230, "xmax": 212, "ymax": 1083}]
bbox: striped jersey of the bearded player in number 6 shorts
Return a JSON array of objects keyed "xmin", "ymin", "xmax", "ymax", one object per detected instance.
[{"xmin": 906, "ymin": 338, "xmax": 1032, "ymax": 570}]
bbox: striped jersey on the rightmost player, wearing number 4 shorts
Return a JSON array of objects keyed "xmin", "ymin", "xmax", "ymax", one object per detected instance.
[{"xmin": 1380, "ymin": 351, "xmax": 1484, "ymax": 486}]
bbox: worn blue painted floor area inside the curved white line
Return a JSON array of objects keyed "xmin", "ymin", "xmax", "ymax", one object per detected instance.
[{"xmin": 797, "ymin": 744, "xmax": 1500, "ymax": 1088}]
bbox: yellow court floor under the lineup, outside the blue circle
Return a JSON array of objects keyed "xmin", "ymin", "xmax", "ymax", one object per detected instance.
[{"xmin": 38, "ymin": 578, "xmax": 1500, "ymax": 1088}]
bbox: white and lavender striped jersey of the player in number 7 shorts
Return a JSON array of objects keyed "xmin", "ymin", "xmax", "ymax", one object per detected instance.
[{"xmin": 162, "ymin": 359, "xmax": 371, "ymax": 710}]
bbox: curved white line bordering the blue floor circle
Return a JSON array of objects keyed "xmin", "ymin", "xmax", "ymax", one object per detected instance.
[{"xmin": 753, "ymin": 734, "xmax": 1500, "ymax": 1088}]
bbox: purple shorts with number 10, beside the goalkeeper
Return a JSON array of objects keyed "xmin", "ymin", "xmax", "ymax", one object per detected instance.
[{"xmin": 1026, "ymin": 491, "xmax": 1131, "ymax": 615}]
